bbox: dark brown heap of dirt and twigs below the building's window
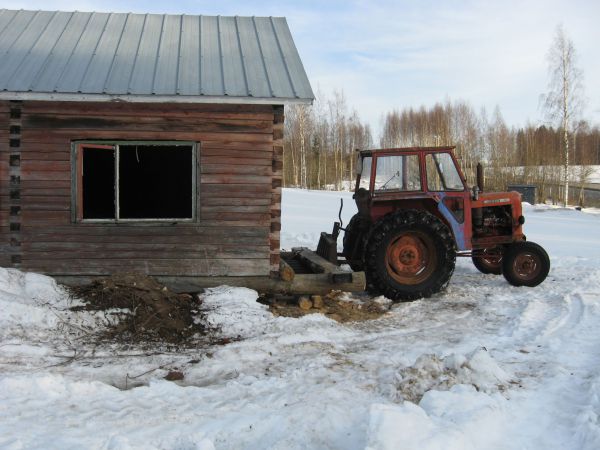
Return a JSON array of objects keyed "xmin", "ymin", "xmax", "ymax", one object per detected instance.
[{"xmin": 68, "ymin": 274, "xmax": 215, "ymax": 344}]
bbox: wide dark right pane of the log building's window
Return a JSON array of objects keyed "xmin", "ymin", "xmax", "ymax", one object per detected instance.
[{"xmin": 119, "ymin": 145, "xmax": 192, "ymax": 219}]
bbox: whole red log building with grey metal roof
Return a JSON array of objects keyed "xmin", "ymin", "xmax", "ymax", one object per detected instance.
[{"xmin": 0, "ymin": 10, "xmax": 314, "ymax": 289}]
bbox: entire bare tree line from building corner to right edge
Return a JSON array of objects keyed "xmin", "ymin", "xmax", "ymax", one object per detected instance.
[{"xmin": 284, "ymin": 93, "xmax": 600, "ymax": 203}]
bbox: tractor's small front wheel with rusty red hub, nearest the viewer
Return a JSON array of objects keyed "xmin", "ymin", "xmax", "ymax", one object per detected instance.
[{"xmin": 502, "ymin": 241, "xmax": 550, "ymax": 287}]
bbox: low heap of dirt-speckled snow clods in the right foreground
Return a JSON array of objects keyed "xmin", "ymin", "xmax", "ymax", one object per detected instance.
[{"xmin": 393, "ymin": 348, "xmax": 512, "ymax": 403}]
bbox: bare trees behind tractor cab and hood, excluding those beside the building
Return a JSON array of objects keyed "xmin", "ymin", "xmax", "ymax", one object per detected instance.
[{"xmin": 380, "ymin": 101, "xmax": 600, "ymax": 204}]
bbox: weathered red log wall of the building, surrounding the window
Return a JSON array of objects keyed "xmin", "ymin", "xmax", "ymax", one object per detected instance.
[{"xmin": 0, "ymin": 101, "xmax": 283, "ymax": 276}]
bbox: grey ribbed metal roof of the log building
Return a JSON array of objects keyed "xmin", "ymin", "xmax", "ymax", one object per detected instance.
[{"xmin": 0, "ymin": 9, "xmax": 314, "ymax": 103}]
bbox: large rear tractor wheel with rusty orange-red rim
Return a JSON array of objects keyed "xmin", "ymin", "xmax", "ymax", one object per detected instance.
[{"xmin": 365, "ymin": 210, "xmax": 456, "ymax": 301}]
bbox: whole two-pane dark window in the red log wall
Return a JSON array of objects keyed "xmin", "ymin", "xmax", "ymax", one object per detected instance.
[{"xmin": 77, "ymin": 143, "xmax": 194, "ymax": 221}]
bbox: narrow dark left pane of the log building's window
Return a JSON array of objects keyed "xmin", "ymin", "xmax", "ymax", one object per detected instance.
[{"xmin": 81, "ymin": 147, "xmax": 115, "ymax": 219}]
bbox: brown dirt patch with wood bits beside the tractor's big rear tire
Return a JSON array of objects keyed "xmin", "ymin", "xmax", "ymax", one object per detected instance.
[{"xmin": 260, "ymin": 291, "xmax": 389, "ymax": 323}]
